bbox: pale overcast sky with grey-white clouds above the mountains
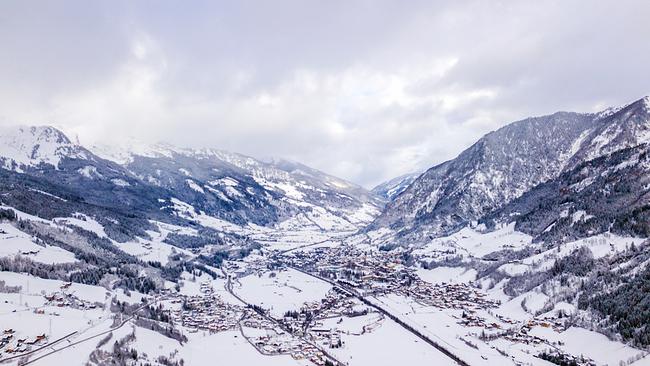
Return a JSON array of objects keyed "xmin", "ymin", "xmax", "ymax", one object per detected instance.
[{"xmin": 0, "ymin": 0, "xmax": 650, "ymax": 187}]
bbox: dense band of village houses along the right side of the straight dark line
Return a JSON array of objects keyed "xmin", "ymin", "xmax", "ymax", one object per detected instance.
[{"xmin": 264, "ymin": 245, "xmax": 594, "ymax": 366}]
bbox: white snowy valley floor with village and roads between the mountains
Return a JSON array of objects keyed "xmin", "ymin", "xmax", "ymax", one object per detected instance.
[{"xmin": 0, "ymin": 213, "xmax": 650, "ymax": 366}]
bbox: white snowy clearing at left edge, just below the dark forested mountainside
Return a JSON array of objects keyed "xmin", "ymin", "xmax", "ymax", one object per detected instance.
[{"xmin": 0, "ymin": 223, "xmax": 77, "ymax": 264}]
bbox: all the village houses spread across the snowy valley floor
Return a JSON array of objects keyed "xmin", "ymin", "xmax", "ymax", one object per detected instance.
[{"xmin": 0, "ymin": 240, "xmax": 593, "ymax": 366}]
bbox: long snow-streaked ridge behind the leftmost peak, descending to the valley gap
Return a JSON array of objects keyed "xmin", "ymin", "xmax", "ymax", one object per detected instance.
[{"xmin": 91, "ymin": 142, "xmax": 382, "ymax": 226}]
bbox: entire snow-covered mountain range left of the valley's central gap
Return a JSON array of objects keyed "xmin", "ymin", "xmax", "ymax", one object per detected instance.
[{"xmin": 0, "ymin": 127, "xmax": 382, "ymax": 240}]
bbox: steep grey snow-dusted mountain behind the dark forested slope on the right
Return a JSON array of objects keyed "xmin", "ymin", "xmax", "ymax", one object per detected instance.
[{"xmin": 369, "ymin": 97, "xmax": 650, "ymax": 242}]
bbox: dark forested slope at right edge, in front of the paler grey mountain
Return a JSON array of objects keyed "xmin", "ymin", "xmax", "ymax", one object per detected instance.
[{"xmin": 483, "ymin": 144, "xmax": 650, "ymax": 243}]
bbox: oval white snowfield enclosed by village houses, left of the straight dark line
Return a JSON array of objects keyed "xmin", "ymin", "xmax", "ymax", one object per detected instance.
[{"xmin": 234, "ymin": 269, "xmax": 332, "ymax": 316}]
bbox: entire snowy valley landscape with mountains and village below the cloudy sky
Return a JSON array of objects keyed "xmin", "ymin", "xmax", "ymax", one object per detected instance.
[{"xmin": 0, "ymin": 97, "xmax": 650, "ymax": 366}]
